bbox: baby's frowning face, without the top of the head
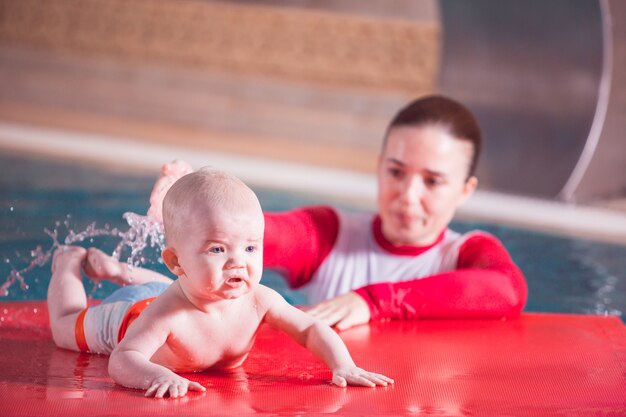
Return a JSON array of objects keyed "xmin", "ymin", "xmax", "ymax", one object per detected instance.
[{"xmin": 176, "ymin": 203, "xmax": 264, "ymax": 300}]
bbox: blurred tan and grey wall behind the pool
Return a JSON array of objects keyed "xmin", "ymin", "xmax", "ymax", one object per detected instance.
[{"xmin": 0, "ymin": 0, "xmax": 626, "ymax": 201}]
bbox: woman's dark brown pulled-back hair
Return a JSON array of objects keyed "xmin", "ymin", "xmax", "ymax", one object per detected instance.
[{"xmin": 383, "ymin": 96, "xmax": 482, "ymax": 178}]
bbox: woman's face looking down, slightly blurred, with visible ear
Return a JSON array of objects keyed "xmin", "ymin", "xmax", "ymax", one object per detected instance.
[{"xmin": 378, "ymin": 124, "xmax": 478, "ymax": 246}]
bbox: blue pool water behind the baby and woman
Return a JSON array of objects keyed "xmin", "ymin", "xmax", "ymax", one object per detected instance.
[{"xmin": 0, "ymin": 153, "xmax": 626, "ymax": 320}]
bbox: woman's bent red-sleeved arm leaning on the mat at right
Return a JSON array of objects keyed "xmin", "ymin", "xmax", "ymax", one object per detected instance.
[{"xmin": 355, "ymin": 234, "xmax": 527, "ymax": 320}]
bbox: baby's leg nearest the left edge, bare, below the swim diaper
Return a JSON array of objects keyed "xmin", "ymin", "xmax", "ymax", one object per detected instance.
[{"xmin": 48, "ymin": 246, "xmax": 87, "ymax": 350}]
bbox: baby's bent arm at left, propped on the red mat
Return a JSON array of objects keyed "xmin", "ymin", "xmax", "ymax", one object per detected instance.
[{"xmin": 109, "ymin": 305, "xmax": 206, "ymax": 398}]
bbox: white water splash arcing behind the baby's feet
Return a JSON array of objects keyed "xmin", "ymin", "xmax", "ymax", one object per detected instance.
[{"xmin": 0, "ymin": 212, "xmax": 165, "ymax": 297}]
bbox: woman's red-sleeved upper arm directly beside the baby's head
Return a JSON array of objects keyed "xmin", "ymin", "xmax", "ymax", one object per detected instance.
[{"xmin": 263, "ymin": 206, "xmax": 339, "ymax": 288}]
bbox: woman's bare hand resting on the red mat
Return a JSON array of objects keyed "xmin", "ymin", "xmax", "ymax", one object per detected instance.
[{"xmin": 307, "ymin": 292, "xmax": 371, "ymax": 330}]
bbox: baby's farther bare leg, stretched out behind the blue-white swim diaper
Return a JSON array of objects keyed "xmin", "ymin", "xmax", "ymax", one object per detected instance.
[{"xmin": 85, "ymin": 248, "xmax": 172, "ymax": 286}]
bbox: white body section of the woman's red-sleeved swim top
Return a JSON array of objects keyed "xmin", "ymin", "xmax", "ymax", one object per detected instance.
[{"xmin": 302, "ymin": 211, "xmax": 480, "ymax": 304}]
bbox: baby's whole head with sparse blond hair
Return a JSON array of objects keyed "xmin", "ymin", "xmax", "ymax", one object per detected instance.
[{"xmin": 163, "ymin": 168, "xmax": 265, "ymax": 298}]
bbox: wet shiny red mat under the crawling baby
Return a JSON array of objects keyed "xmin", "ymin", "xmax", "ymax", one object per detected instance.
[{"xmin": 0, "ymin": 302, "xmax": 626, "ymax": 417}]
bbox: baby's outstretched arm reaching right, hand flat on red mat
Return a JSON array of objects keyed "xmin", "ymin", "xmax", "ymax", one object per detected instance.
[{"xmin": 259, "ymin": 286, "xmax": 393, "ymax": 387}]
